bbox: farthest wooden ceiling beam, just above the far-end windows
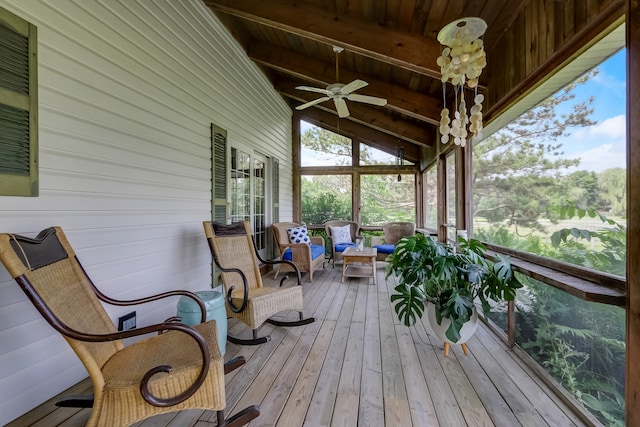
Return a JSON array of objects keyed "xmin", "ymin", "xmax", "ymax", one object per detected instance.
[{"xmin": 291, "ymin": 108, "xmax": 420, "ymax": 163}]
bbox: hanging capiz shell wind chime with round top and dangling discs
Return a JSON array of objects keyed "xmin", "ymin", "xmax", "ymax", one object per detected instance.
[{"xmin": 437, "ymin": 18, "xmax": 487, "ymax": 147}]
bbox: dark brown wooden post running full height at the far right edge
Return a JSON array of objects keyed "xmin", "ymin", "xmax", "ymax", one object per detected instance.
[{"xmin": 625, "ymin": 0, "xmax": 640, "ymax": 426}]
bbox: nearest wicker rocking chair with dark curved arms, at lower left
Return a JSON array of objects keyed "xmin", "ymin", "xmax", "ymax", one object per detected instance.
[{"xmin": 0, "ymin": 227, "xmax": 260, "ymax": 426}]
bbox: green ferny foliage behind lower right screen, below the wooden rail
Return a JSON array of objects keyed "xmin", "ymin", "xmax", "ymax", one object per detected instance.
[{"xmin": 516, "ymin": 278, "xmax": 625, "ymax": 425}]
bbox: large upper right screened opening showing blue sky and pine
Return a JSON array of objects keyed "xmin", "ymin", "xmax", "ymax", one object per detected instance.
[{"xmin": 473, "ymin": 50, "xmax": 627, "ymax": 276}]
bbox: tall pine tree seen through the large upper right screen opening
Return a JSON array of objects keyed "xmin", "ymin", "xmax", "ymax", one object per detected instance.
[{"xmin": 472, "ymin": 70, "xmax": 598, "ymax": 231}]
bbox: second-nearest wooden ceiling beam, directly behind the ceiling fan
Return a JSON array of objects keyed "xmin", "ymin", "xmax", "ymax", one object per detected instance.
[{"xmin": 247, "ymin": 41, "xmax": 442, "ymax": 125}]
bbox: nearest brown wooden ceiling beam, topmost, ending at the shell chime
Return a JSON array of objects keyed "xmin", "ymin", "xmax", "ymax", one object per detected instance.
[{"xmin": 204, "ymin": 0, "xmax": 441, "ymax": 79}]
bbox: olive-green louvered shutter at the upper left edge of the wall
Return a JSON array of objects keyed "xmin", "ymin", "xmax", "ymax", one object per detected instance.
[{"xmin": 0, "ymin": 9, "xmax": 38, "ymax": 196}]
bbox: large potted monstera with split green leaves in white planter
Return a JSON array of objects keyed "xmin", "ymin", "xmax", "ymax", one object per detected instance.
[{"xmin": 386, "ymin": 234, "xmax": 522, "ymax": 351}]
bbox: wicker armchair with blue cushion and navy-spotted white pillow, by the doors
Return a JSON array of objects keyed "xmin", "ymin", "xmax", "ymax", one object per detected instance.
[{"xmin": 271, "ymin": 222, "xmax": 325, "ymax": 282}]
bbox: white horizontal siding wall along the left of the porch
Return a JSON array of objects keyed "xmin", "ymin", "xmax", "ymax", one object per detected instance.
[{"xmin": 0, "ymin": 0, "xmax": 291, "ymax": 424}]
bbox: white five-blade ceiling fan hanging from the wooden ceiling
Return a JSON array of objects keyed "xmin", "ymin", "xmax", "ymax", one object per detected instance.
[{"xmin": 296, "ymin": 46, "xmax": 387, "ymax": 118}]
